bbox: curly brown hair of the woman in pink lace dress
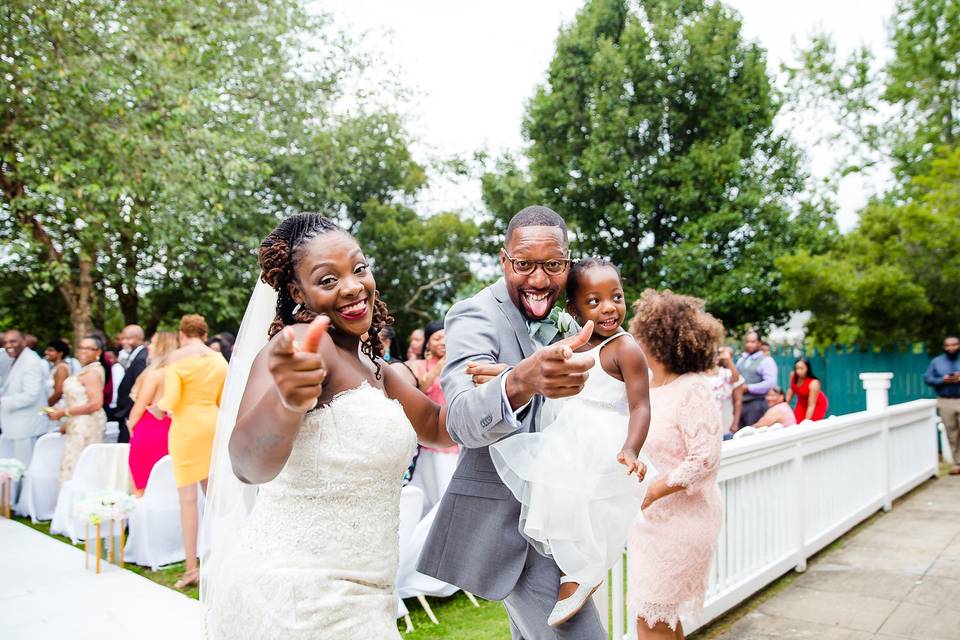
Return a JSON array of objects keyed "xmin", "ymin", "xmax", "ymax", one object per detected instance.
[{"xmin": 630, "ymin": 289, "xmax": 723, "ymax": 374}]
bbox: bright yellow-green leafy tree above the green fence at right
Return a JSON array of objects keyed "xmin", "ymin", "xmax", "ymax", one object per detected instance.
[{"xmin": 778, "ymin": 146, "xmax": 960, "ymax": 346}]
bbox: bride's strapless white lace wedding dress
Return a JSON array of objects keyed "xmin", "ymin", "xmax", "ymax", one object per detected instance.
[{"xmin": 206, "ymin": 384, "xmax": 416, "ymax": 640}]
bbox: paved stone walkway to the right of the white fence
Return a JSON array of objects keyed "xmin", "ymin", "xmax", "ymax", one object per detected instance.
[{"xmin": 721, "ymin": 476, "xmax": 960, "ymax": 640}]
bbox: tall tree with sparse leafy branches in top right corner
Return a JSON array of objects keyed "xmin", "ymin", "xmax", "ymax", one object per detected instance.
[{"xmin": 785, "ymin": 0, "xmax": 960, "ymax": 188}]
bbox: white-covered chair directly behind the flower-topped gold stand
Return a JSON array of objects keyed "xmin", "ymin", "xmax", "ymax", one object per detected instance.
[{"xmin": 50, "ymin": 443, "xmax": 130, "ymax": 544}]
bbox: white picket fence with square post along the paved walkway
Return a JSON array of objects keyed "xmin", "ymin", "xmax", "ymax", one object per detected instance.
[{"xmin": 595, "ymin": 374, "xmax": 938, "ymax": 639}]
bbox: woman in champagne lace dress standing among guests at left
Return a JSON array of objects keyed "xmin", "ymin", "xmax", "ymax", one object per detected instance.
[{"xmin": 47, "ymin": 335, "xmax": 107, "ymax": 486}]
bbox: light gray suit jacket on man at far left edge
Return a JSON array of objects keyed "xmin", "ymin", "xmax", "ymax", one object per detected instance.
[{"xmin": 0, "ymin": 349, "xmax": 52, "ymax": 440}]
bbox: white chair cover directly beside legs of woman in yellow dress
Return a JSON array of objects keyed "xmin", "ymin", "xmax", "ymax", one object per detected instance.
[{"xmin": 123, "ymin": 455, "xmax": 185, "ymax": 571}]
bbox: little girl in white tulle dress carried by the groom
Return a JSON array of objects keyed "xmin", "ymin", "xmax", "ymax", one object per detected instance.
[{"xmin": 490, "ymin": 258, "xmax": 652, "ymax": 627}]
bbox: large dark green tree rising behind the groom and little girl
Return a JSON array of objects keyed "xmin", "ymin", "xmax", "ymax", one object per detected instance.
[{"xmin": 484, "ymin": 0, "xmax": 832, "ymax": 326}]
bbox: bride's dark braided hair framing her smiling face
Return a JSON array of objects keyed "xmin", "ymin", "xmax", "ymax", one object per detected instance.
[{"xmin": 260, "ymin": 213, "xmax": 393, "ymax": 378}]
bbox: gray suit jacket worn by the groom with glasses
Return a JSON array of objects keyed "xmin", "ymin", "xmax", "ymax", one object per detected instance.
[{"xmin": 418, "ymin": 280, "xmax": 563, "ymax": 600}]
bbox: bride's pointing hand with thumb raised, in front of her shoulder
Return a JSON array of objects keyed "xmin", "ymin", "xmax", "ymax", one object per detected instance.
[{"xmin": 267, "ymin": 316, "xmax": 330, "ymax": 413}]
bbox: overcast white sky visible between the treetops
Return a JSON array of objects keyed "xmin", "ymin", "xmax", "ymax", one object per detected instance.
[{"xmin": 314, "ymin": 0, "xmax": 893, "ymax": 229}]
